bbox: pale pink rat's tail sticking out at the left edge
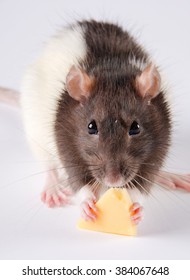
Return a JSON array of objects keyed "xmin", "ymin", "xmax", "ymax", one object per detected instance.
[{"xmin": 0, "ymin": 87, "xmax": 20, "ymax": 107}]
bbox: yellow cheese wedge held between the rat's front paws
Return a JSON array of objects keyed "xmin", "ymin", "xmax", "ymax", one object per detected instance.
[{"xmin": 77, "ymin": 188, "xmax": 136, "ymax": 235}]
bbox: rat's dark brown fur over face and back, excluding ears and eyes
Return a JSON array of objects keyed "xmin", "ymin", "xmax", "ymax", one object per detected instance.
[{"xmin": 55, "ymin": 21, "xmax": 171, "ymax": 195}]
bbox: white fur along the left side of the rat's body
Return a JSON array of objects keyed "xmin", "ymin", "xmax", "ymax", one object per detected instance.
[{"xmin": 21, "ymin": 26, "xmax": 86, "ymax": 166}]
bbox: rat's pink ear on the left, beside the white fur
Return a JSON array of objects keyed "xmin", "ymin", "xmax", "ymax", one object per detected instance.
[{"xmin": 66, "ymin": 65, "xmax": 94, "ymax": 102}]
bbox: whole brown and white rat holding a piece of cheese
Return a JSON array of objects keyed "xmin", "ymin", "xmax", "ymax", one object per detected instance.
[{"xmin": 0, "ymin": 20, "xmax": 190, "ymax": 224}]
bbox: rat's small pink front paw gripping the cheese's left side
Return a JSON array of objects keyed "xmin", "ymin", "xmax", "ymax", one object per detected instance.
[{"xmin": 81, "ymin": 197, "xmax": 98, "ymax": 221}]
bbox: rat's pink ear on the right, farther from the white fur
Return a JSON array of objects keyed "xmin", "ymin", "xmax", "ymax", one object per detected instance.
[{"xmin": 136, "ymin": 63, "xmax": 161, "ymax": 99}]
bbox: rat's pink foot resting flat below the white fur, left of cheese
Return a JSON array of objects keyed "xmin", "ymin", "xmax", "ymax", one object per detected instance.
[{"xmin": 41, "ymin": 187, "xmax": 72, "ymax": 208}]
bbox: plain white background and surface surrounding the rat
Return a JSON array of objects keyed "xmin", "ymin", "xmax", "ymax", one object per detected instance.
[{"xmin": 0, "ymin": 0, "xmax": 190, "ymax": 259}]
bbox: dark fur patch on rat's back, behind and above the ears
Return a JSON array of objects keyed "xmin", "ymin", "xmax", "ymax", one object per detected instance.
[{"xmin": 79, "ymin": 21, "xmax": 148, "ymax": 72}]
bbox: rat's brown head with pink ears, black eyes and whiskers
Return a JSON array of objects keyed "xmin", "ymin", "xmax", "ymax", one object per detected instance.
[{"xmin": 55, "ymin": 64, "xmax": 171, "ymax": 194}]
